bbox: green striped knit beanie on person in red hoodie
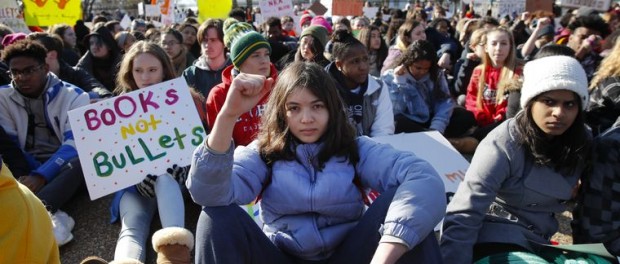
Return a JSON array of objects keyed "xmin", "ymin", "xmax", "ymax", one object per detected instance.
[{"xmin": 224, "ymin": 18, "xmax": 271, "ymax": 69}]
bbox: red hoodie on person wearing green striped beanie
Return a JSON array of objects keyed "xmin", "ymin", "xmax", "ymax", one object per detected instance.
[{"xmin": 207, "ymin": 63, "xmax": 278, "ymax": 146}]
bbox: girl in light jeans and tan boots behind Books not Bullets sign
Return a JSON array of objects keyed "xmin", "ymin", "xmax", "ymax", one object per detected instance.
[{"xmin": 111, "ymin": 41, "xmax": 194, "ymax": 263}]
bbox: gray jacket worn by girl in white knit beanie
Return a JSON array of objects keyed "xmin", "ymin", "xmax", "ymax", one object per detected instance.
[{"xmin": 440, "ymin": 119, "xmax": 583, "ymax": 264}]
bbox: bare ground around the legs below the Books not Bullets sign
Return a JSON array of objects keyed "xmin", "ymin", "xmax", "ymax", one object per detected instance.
[{"xmin": 60, "ymin": 192, "xmax": 200, "ymax": 264}]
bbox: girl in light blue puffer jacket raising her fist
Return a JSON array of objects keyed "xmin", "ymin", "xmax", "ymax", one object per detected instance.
[{"xmin": 187, "ymin": 62, "xmax": 445, "ymax": 263}]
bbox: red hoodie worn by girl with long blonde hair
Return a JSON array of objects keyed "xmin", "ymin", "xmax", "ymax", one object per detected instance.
[{"xmin": 465, "ymin": 66, "xmax": 521, "ymax": 127}]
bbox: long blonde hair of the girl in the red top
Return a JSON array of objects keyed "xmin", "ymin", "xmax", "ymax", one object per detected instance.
[{"xmin": 476, "ymin": 27, "xmax": 519, "ymax": 109}]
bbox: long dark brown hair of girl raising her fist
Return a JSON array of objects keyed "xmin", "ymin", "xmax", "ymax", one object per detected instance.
[{"xmin": 257, "ymin": 61, "xmax": 359, "ymax": 168}]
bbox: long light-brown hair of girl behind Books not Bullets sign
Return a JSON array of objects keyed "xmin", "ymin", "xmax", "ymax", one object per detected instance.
[{"xmin": 114, "ymin": 40, "xmax": 176, "ymax": 94}]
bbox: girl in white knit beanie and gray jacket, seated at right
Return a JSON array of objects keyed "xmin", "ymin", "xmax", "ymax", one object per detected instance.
[{"xmin": 441, "ymin": 55, "xmax": 605, "ymax": 264}]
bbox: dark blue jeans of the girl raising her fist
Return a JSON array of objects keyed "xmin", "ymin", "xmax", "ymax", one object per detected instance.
[{"xmin": 195, "ymin": 189, "xmax": 442, "ymax": 264}]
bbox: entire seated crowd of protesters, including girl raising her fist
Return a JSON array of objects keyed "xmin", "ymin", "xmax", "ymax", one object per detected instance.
[{"xmin": 0, "ymin": 1, "xmax": 620, "ymax": 264}]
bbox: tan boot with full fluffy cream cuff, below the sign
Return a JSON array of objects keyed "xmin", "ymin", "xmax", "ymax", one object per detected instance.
[{"xmin": 153, "ymin": 227, "xmax": 194, "ymax": 264}]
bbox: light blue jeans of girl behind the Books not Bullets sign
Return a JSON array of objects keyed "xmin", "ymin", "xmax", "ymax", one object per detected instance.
[{"xmin": 114, "ymin": 174, "xmax": 185, "ymax": 262}]
